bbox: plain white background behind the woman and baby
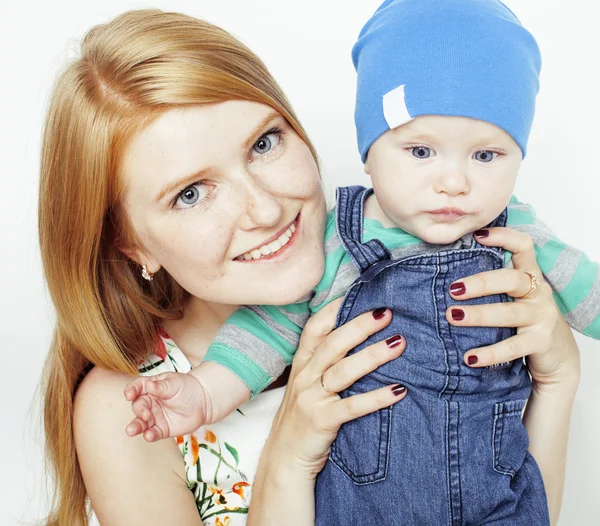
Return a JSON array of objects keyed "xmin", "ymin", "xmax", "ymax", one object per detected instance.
[{"xmin": 0, "ymin": 0, "xmax": 600, "ymax": 526}]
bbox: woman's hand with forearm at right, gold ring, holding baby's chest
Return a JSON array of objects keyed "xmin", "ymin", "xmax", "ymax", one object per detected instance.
[{"xmin": 446, "ymin": 228, "xmax": 579, "ymax": 525}]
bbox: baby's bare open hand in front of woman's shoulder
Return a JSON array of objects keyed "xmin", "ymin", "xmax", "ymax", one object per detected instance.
[{"xmin": 125, "ymin": 373, "xmax": 210, "ymax": 442}]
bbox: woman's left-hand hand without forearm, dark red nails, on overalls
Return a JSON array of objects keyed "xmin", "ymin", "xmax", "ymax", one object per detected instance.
[{"xmin": 272, "ymin": 299, "xmax": 406, "ymax": 477}]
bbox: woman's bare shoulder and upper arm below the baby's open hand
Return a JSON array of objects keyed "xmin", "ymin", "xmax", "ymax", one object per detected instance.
[{"xmin": 73, "ymin": 367, "xmax": 198, "ymax": 524}]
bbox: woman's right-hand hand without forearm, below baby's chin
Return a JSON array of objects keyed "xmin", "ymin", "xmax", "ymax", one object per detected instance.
[{"xmin": 446, "ymin": 227, "xmax": 579, "ymax": 387}]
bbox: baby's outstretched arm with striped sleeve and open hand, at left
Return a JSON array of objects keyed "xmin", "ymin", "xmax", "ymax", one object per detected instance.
[{"xmin": 125, "ymin": 303, "xmax": 309, "ymax": 442}]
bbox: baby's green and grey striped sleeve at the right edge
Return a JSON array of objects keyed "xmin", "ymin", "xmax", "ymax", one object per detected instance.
[{"xmin": 507, "ymin": 197, "xmax": 600, "ymax": 340}]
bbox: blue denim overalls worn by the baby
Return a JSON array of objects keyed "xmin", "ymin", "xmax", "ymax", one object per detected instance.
[{"xmin": 316, "ymin": 187, "xmax": 550, "ymax": 526}]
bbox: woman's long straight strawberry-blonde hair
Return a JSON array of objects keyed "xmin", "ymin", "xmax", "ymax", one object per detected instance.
[{"xmin": 39, "ymin": 10, "xmax": 316, "ymax": 526}]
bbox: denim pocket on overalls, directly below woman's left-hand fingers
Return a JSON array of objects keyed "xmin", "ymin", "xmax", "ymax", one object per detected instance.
[{"xmin": 330, "ymin": 400, "xmax": 392, "ymax": 484}]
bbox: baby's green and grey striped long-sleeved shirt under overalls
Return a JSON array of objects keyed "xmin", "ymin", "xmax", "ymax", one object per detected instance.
[{"xmin": 205, "ymin": 197, "xmax": 600, "ymax": 395}]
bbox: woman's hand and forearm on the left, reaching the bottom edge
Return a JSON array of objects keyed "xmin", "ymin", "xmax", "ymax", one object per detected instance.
[{"xmin": 248, "ymin": 299, "xmax": 406, "ymax": 526}]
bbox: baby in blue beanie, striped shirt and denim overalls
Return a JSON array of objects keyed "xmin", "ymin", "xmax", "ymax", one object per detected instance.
[{"xmin": 129, "ymin": 0, "xmax": 600, "ymax": 525}]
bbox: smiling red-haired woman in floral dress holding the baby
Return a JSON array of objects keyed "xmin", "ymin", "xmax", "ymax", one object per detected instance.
[{"xmin": 40, "ymin": 11, "xmax": 579, "ymax": 526}]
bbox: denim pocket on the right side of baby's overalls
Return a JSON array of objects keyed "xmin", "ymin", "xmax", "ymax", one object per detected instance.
[{"xmin": 492, "ymin": 400, "xmax": 529, "ymax": 477}]
